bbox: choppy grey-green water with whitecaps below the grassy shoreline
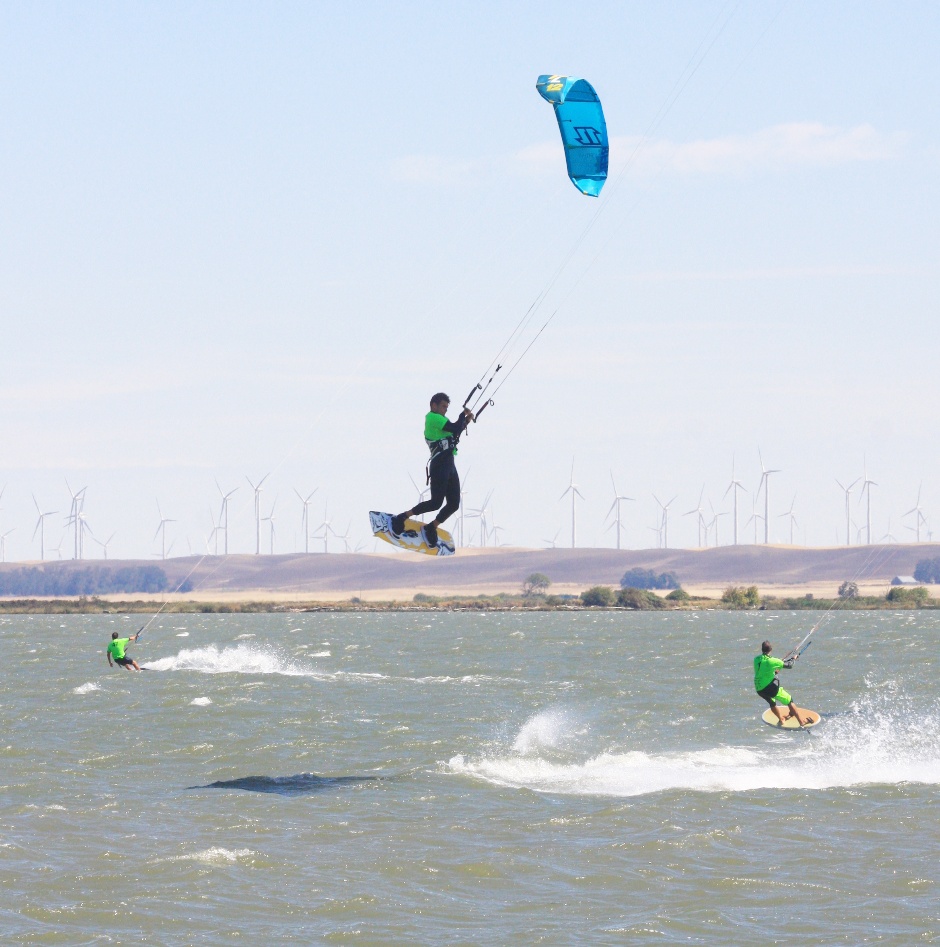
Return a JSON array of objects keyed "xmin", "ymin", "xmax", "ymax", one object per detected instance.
[{"xmin": 0, "ymin": 612, "xmax": 940, "ymax": 945}]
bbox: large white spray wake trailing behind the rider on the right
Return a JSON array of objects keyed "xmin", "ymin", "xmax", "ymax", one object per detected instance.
[{"xmin": 444, "ymin": 702, "xmax": 940, "ymax": 796}]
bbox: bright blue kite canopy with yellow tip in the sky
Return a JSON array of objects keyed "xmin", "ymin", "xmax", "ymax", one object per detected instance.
[{"xmin": 535, "ymin": 76, "xmax": 610, "ymax": 197}]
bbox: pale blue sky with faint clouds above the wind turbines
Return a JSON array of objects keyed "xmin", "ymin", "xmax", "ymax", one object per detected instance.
[{"xmin": 0, "ymin": 0, "xmax": 940, "ymax": 559}]
